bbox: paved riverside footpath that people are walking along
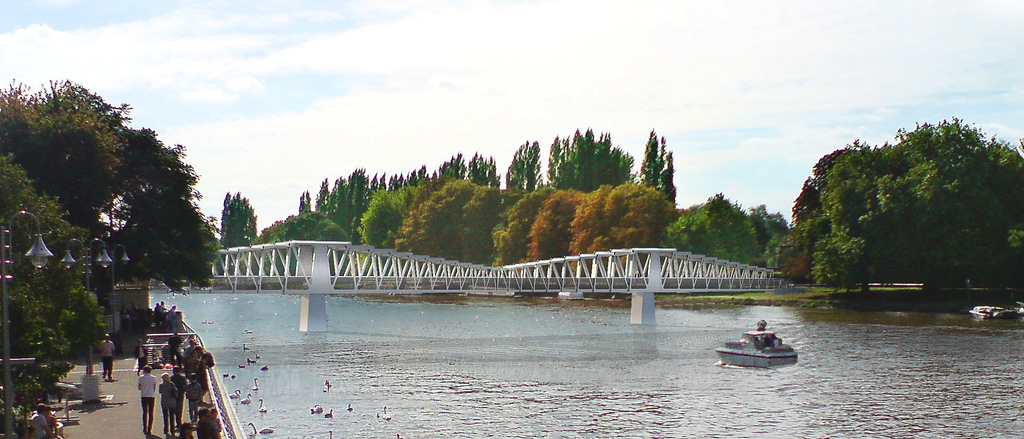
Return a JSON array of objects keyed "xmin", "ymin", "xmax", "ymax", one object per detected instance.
[{"xmin": 58, "ymin": 329, "xmax": 237, "ymax": 439}]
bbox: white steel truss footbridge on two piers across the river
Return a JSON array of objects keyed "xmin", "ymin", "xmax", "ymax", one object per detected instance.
[{"xmin": 213, "ymin": 240, "xmax": 783, "ymax": 331}]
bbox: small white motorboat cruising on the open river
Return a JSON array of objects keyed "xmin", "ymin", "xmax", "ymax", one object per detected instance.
[{"xmin": 715, "ymin": 320, "xmax": 797, "ymax": 367}]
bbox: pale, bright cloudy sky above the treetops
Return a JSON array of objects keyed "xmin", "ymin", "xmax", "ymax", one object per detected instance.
[{"xmin": 0, "ymin": 0, "xmax": 1024, "ymax": 229}]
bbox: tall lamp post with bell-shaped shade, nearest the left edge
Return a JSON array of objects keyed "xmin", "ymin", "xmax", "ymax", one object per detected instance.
[{"xmin": 0, "ymin": 211, "xmax": 53, "ymax": 438}]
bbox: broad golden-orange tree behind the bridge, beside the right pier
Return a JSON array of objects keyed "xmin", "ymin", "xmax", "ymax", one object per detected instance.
[{"xmin": 569, "ymin": 183, "xmax": 674, "ymax": 254}]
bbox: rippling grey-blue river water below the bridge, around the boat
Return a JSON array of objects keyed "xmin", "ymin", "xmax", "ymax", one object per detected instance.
[{"xmin": 153, "ymin": 294, "xmax": 1024, "ymax": 438}]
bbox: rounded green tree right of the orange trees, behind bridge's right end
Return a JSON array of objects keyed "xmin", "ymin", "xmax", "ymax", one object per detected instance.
[{"xmin": 666, "ymin": 193, "xmax": 758, "ymax": 264}]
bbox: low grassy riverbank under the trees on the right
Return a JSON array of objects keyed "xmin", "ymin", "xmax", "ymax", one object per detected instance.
[{"xmin": 656, "ymin": 288, "xmax": 1024, "ymax": 313}]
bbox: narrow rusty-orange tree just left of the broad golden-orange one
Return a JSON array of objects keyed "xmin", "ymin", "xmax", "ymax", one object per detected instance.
[{"xmin": 528, "ymin": 190, "xmax": 583, "ymax": 261}]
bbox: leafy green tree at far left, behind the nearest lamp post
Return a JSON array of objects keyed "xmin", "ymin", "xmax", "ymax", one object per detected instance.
[{"xmin": 0, "ymin": 155, "xmax": 105, "ymax": 413}]
